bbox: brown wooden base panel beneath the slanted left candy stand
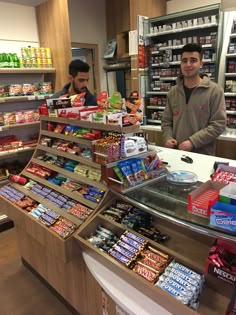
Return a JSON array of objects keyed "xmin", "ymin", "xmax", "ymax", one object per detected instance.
[{"xmin": 17, "ymin": 227, "xmax": 88, "ymax": 315}]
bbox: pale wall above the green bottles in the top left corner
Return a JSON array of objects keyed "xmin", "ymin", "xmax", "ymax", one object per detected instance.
[{"xmin": 0, "ymin": 2, "xmax": 39, "ymax": 55}]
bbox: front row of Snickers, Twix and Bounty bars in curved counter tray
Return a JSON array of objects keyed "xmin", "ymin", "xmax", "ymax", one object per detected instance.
[{"xmin": 87, "ymin": 226, "xmax": 204, "ymax": 309}]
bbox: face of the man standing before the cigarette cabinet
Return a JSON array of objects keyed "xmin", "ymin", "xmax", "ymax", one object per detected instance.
[{"xmin": 180, "ymin": 51, "xmax": 203, "ymax": 78}]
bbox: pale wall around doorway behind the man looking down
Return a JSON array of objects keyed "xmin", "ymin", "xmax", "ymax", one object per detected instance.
[{"xmin": 68, "ymin": 0, "xmax": 106, "ymax": 91}]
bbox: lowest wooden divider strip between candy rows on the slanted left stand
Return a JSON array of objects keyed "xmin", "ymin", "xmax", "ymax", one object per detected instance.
[{"xmin": 11, "ymin": 183, "xmax": 83, "ymax": 226}]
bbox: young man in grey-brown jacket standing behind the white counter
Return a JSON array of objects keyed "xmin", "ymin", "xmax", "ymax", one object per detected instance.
[{"xmin": 162, "ymin": 44, "xmax": 226, "ymax": 155}]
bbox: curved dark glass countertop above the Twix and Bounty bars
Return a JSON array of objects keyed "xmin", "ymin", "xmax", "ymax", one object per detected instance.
[{"xmin": 118, "ymin": 177, "xmax": 236, "ymax": 241}]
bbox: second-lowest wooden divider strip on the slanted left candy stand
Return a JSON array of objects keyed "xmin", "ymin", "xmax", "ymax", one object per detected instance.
[{"xmin": 31, "ymin": 158, "xmax": 107, "ymax": 190}]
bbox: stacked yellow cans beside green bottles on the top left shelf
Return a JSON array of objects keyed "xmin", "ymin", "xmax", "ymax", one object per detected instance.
[{"xmin": 19, "ymin": 47, "xmax": 52, "ymax": 68}]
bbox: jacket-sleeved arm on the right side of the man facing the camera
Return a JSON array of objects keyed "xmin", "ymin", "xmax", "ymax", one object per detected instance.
[{"xmin": 189, "ymin": 87, "xmax": 226, "ymax": 148}]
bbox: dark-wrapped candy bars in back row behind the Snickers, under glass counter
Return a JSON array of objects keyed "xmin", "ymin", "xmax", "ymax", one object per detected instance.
[{"xmin": 102, "ymin": 200, "xmax": 169, "ymax": 243}]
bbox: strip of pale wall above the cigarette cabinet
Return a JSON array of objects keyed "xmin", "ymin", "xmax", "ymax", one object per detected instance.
[{"xmin": 166, "ymin": 0, "xmax": 220, "ymax": 14}]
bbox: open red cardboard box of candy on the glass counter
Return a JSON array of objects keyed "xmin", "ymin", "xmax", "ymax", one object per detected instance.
[{"xmin": 188, "ymin": 180, "xmax": 225, "ymax": 218}]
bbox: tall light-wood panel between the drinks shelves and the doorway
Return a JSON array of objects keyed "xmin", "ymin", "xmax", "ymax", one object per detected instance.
[{"xmin": 36, "ymin": 0, "xmax": 72, "ymax": 91}]
